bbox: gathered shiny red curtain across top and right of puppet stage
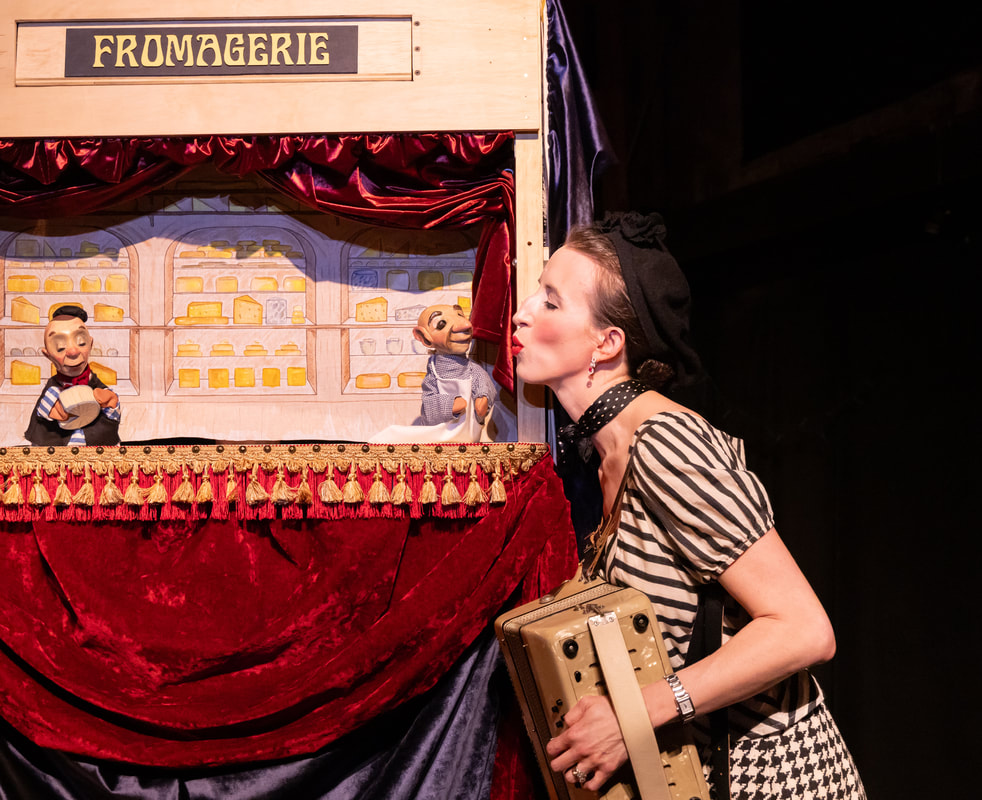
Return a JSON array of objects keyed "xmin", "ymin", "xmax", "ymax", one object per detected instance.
[{"xmin": 0, "ymin": 133, "xmax": 515, "ymax": 391}]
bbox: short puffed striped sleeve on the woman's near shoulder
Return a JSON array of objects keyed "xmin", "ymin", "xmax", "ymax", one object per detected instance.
[{"xmin": 631, "ymin": 414, "xmax": 774, "ymax": 581}]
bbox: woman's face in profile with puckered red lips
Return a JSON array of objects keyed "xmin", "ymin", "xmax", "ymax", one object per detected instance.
[{"xmin": 512, "ymin": 247, "xmax": 603, "ymax": 389}]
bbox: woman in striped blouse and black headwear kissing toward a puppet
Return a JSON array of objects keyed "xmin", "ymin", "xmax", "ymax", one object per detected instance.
[{"xmin": 514, "ymin": 213, "xmax": 866, "ymax": 800}]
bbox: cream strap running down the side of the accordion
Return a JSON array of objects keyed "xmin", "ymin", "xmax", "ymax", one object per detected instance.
[{"xmin": 588, "ymin": 612, "xmax": 672, "ymax": 800}]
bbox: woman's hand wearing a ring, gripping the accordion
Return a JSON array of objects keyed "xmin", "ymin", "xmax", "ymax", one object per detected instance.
[{"xmin": 546, "ymin": 695, "xmax": 627, "ymax": 792}]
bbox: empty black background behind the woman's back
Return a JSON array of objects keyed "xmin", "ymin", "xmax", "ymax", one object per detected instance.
[{"xmin": 562, "ymin": 0, "xmax": 982, "ymax": 800}]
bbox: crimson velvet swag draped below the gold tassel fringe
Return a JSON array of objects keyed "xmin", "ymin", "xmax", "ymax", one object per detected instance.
[{"xmin": 0, "ymin": 458, "xmax": 575, "ymax": 767}]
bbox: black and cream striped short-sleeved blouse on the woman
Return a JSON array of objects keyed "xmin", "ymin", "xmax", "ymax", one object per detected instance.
[{"xmin": 604, "ymin": 412, "xmax": 822, "ymax": 738}]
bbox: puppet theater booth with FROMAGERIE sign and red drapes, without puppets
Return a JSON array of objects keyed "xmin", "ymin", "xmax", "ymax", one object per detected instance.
[{"xmin": 0, "ymin": 0, "xmax": 575, "ymax": 800}]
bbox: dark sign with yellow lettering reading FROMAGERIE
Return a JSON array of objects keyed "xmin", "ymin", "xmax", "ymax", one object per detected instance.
[{"xmin": 65, "ymin": 22, "xmax": 358, "ymax": 78}]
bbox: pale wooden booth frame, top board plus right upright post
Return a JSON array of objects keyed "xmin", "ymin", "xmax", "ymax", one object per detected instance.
[{"xmin": 0, "ymin": 0, "xmax": 546, "ymax": 442}]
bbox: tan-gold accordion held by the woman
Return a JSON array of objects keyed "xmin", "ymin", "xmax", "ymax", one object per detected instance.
[{"xmin": 495, "ymin": 581, "xmax": 709, "ymax": 800}]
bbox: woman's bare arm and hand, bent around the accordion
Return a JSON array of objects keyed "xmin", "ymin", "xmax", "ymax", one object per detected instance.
[{"xmin": 547, "ymin": 528, "xmax": 835, "ymax": 791}]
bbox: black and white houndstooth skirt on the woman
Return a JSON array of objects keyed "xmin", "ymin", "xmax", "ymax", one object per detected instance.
[{"xmin": 714, "ymin": 704, "xmax": 866, "ymax": 800}]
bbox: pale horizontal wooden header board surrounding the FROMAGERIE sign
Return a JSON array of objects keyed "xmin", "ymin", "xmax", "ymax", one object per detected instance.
[{"xmin": 0, "ymin": 0, "xmax": 541, "ymax": 137}]
